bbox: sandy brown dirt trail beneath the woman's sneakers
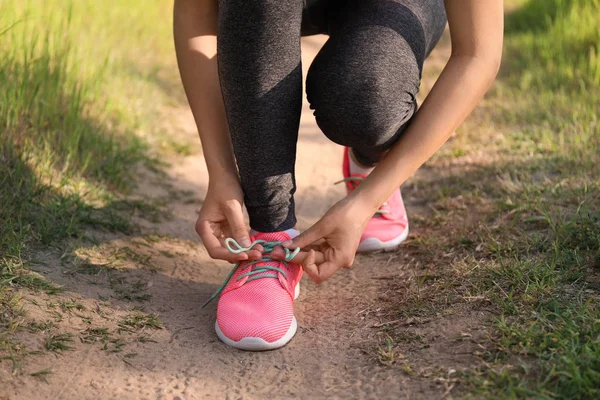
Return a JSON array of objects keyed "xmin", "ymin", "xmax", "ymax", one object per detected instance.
[{"xmin": 0, "ymin": 37, "xmax": 486, "ymax": 399}]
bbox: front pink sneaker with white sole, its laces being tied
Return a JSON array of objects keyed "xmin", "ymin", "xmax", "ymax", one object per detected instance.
[{"xmin": 213, "ymin": 232, "xmax": 302, "ymax": 351}]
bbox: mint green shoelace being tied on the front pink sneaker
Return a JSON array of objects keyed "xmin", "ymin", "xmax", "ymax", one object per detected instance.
[{"xmin": 202, "ymin": 238, "xmax": 300, "ymax": 308}]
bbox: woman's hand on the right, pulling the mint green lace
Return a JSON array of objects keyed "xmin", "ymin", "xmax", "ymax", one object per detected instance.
[{"xmin": 283, "ymin": 196, "xmax": 374, "ymax": 284}]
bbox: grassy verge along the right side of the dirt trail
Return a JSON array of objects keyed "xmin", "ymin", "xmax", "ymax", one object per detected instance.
[{"xmin": 387, "ymin": 0, "xmax": 600, "ymax": 399}]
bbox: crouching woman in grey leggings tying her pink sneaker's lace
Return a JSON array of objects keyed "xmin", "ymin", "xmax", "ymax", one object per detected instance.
[{"xmin": 174, "ymin": 0, "xmax": 503, "ymax": 350}]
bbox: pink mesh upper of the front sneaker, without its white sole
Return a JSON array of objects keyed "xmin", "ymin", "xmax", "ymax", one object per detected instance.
[{"xmin": 217, "ymin": 232, "xmax": 302, "ymax": 343}]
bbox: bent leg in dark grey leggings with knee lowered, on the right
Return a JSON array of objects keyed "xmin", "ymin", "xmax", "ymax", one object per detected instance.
[{"xmin": 306, "ymin": 0, "xmax": 446, "ymax": 165}]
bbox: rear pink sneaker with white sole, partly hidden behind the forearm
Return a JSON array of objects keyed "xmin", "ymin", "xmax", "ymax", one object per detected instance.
[{"xmin": 342, "ymin": 147, "xmax": 408, "ymax": 252}]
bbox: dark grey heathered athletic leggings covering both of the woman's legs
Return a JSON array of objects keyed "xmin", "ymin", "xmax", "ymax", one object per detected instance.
[{"xmin": 218, "ymin": 0, "xmax": 446, "ymax": 232}]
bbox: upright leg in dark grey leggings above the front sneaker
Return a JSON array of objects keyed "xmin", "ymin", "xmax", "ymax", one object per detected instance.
[{"xmin": 218, "ymin": 0, "xmax": 303, "ymax": 232}]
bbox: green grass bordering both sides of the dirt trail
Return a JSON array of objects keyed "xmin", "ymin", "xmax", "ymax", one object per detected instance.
[{"xmin": 0, "ymin": 0, "xmax": 600, "ymax": 399}]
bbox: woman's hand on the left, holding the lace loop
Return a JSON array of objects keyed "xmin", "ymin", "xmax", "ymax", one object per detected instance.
[{"xmin": 196, "ymin": 177, "xmax": 263, "ymax": 263}]
